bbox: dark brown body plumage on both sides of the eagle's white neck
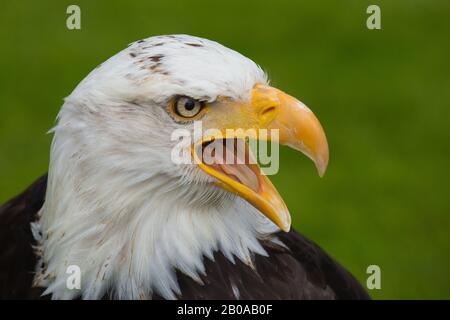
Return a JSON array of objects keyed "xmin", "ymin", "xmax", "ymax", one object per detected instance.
[{"xmin": 0, "ymin": 176, "xmax": 369, "ymax": 299}]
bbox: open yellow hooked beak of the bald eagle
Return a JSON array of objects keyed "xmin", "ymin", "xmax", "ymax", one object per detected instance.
[{"xmin": 192, "ymin": 84, "xmax": 328, "ymax": 232}]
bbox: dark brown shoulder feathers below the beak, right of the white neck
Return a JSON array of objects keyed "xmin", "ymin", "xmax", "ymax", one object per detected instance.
[{"xmin": 172, "ymin": 231, "xmax": 370, "ymax": 300}]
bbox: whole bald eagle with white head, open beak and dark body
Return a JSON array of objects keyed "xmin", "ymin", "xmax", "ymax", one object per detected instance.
[{"xmin": 0, "ymin": 35, "xmax": 369, "ymax": 299}]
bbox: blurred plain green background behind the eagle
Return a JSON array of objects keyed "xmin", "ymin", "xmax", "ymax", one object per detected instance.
[{"xmin": 0, "ymin": 0, "xmax": 450, "ymax": 299}]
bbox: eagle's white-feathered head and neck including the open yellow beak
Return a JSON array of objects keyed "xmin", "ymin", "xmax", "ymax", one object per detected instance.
[{"xmin": 34, "ymin": 35, "xmax": 328, "ymax": 298}]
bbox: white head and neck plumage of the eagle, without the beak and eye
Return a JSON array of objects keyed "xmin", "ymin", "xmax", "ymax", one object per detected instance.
[{"xmin": 33, "ymin": 35, "xmax": 278, "ymax": 299}]
